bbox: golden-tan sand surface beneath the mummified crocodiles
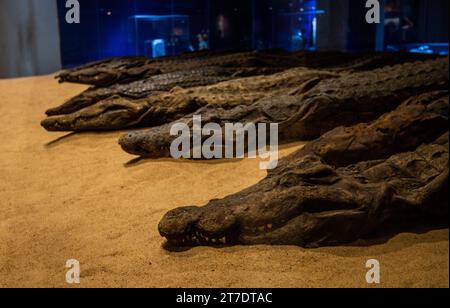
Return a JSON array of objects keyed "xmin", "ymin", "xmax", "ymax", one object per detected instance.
[{"xmin": 0, "ymin": 76, "xmax": 449, "ymax": 287}]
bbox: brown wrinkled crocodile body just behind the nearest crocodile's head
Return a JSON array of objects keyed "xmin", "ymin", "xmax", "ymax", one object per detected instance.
[{"xmin": 296, "ymin": 91, "xmax": 449, "ymax": 168}]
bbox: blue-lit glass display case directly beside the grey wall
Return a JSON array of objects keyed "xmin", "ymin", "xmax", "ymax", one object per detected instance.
[{"xmin": 58, "ymin": 0, "xmax": 210, "ymax": 68}]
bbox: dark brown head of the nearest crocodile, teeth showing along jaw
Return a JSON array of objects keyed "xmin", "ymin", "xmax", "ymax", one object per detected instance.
[{"xmin": 159, "ymin": 156, "xmax": 372, "ymax": 246}]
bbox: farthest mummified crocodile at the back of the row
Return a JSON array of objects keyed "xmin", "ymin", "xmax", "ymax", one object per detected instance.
[{"xmin": 57, "ymin": 51, "xmax": 301, "ymax": 87}]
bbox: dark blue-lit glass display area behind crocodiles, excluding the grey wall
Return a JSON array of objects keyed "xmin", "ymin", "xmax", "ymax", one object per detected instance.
[{"xmin": 58, "ymin": 0, "xmax": 449, "ymax": 68}]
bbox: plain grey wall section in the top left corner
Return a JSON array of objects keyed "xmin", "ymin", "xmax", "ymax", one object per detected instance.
[{"xmin": 0, "ymin": 0, "xmax": 61, "ymax": 78}]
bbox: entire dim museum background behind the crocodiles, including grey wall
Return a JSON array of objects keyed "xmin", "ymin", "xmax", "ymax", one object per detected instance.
[{"xmin": 0, "ymin": 0, "xmax": 449, "ymax": 78}]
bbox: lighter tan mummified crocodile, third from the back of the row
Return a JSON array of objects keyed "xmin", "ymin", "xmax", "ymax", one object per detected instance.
[{"xmin": 42, "ymin": 68, "xmax": 340, "ymax": 131}]
